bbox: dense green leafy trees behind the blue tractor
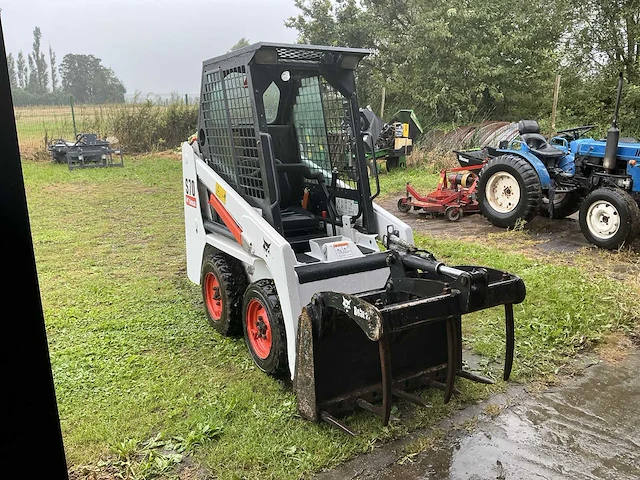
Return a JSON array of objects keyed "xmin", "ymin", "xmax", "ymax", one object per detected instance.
[{"xmin": 285, "ymin": 0, "xmax": 640, "ymax": 135}]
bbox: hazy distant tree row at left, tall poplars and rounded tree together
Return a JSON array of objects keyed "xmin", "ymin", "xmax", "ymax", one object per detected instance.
[{"xmin": 7, "ymin": 27, "xmax": 126, "ymax": 106}]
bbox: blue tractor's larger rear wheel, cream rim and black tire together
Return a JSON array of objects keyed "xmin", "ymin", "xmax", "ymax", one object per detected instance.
[{"xmin": 478, "ymin": 155, "xmax": 542, "ymax": 228}]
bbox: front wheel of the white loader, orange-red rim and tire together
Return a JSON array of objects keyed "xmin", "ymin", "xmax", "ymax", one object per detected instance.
[{"xmin": 242, "ymin": 280, "xmax": 289, "ymax": 377}]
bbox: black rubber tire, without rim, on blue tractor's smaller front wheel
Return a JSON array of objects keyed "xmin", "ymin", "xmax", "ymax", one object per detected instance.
[{"xmin": 579, "ymin": 187, "xmax": 640, "ymax": 250}]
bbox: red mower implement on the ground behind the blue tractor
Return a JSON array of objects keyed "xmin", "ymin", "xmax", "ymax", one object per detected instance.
[{"xmin": 398, "ymin": 164, "xmax": 483, "ymax": 222}]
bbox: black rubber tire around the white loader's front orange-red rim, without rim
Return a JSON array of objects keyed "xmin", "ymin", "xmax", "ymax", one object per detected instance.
[{"xmin": 242, "ymin": 280, "xmax": 289, "ymax": 377}]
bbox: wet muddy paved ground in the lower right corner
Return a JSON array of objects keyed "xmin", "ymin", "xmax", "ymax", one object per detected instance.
[{"xmin": 316, "ymin": 352, "xmax": 640, "ymax": 480}]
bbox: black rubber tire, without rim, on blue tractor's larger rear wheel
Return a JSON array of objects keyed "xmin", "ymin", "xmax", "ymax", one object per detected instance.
[{"xmin": 478, "ymin": 155, "xmax": 542, "ymax": 228}]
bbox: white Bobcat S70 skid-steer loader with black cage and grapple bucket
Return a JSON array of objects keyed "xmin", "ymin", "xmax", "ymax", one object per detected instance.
[{"xmin": 182, "ymin": 43, "xmax": 525, "ymax": 433}]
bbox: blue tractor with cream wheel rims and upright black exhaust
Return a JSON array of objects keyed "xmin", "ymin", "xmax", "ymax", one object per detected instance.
[{"xmin": 457, "ymin": 75, "xmax": 640, "ymax": 249}]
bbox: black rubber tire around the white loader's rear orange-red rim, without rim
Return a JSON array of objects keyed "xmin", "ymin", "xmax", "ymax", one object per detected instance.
[{"xmin": 200, "ymin": 253, "xmax": 247, "ymax": 336}]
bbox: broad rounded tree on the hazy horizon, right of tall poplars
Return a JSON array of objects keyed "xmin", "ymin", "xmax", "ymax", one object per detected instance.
[{"xmin": 60, "ymin": 54, "xmax": 126, "ymax": 103}]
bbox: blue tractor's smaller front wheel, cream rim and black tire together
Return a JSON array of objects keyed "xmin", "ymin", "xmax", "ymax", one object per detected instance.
[{"xmin": 579, "ymin": 187, "xmax": 640, "ymax": 250}]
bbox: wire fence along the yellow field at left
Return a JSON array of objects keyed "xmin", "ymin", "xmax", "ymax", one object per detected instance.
[{"xmin": 14, "ymin": 94, "xmax": 199, "ymax": 157}]
